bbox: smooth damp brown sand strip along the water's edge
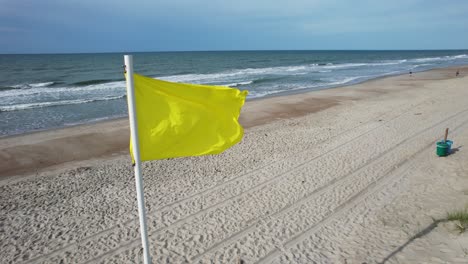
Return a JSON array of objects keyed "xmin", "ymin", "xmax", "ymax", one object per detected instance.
[{"xmin": 0, "ymin": 66, "xmax": 468, "ymax": 178}]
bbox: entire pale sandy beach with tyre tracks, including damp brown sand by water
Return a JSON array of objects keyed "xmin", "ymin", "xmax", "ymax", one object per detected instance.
[{"xmin": 0, "ymin": 67, "xmax": 468, "ymax": 263}]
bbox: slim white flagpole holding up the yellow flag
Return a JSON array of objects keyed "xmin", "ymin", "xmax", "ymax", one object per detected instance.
[{"xmin": 124, "ymin": 55, "xmax": 151, "ymax": 264}]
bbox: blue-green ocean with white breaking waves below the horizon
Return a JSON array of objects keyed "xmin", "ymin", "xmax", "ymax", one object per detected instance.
[{"xmin": 0, "ymin": 50, "xmax": 468, "ymax": 136}]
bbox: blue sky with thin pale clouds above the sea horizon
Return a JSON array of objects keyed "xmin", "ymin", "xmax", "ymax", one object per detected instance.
[{"xmin": 0, "ymin": 0, "xmax": 468, "ymax": 53}]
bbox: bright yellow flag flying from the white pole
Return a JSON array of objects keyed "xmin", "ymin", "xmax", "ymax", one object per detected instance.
[{"xmin": 130, "ymin": 74, "xmax": 248, "ymax": 161}]
